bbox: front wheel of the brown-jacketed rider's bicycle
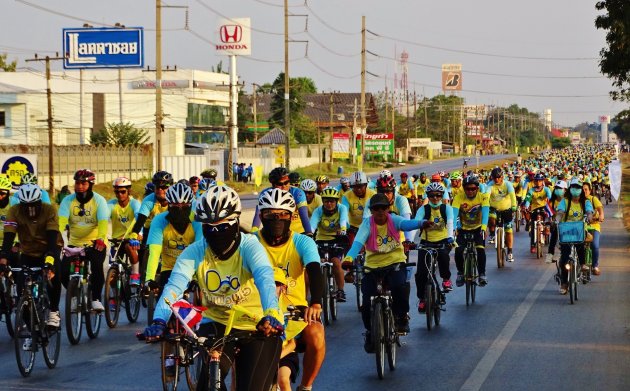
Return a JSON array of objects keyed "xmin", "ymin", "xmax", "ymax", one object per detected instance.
[{"xmin": 13, "ymin": 297, "xmax": 37, "ymax": 377}]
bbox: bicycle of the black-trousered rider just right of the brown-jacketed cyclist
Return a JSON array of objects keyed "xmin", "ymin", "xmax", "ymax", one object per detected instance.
[{"xmin": 63, "ymin": 247, "xmax": 101, "ymax": 345}]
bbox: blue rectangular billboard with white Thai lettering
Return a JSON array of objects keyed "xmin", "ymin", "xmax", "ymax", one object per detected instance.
[{"xmin": 63, "ymin": 27, "xmax": 144, "ymax": 69}]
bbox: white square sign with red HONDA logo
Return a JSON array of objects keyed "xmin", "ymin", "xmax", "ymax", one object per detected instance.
[{"xmin": 215, "ymin": 18, "xmax": 252, "ymax": 56}]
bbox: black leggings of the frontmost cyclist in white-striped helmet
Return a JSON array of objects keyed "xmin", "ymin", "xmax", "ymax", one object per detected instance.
[{"xmin": 197, "ymin": 323, "xmax": 282, "ymax": 391}]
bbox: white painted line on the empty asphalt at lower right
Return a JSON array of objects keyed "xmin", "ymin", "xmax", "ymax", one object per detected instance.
[{"xmin": 460, "ymin": 265, "xmax": 556, "ymax": 391}]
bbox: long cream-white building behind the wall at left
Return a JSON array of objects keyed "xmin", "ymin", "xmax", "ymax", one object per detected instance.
[{"xmin": 0, "ymin": 69, "xmax": 230, "ymax": 156}]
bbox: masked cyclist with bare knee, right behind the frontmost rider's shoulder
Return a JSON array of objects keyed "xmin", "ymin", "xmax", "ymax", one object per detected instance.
[{"xmin": 255, "ymin": 189, "xmax": 326, "ymax": 390}]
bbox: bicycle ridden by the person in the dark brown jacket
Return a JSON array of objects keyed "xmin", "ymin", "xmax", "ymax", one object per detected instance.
[{"xmin": 11, "ymin": 266, "xmax": 61, "ymax": 377}]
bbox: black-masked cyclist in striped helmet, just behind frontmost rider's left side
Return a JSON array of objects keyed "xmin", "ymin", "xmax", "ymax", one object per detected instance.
[{"xmin": 145, "ymin": 183, "xmax": 203, "ymax": 289}]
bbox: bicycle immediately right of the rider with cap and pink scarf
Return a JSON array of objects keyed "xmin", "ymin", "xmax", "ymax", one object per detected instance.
[{"xmin": 416, "ymin": 242, "xmax": 447, "ymax": 331}]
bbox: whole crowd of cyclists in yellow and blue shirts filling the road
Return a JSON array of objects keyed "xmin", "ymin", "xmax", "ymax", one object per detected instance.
[{"xmin": 0, "ymin": 145, "xmax": 615, "ymax": 390}]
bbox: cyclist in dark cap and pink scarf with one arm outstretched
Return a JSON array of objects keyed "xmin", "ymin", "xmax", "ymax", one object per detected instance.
[{"xmin": 344, "ymin": 194, "xmax": 433, "ymax": 353}]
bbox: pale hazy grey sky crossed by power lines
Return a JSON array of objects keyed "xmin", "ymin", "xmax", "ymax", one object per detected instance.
[{"xmin": 0, "ymin": 0, "xmax": 627, "ymax": 126}]
